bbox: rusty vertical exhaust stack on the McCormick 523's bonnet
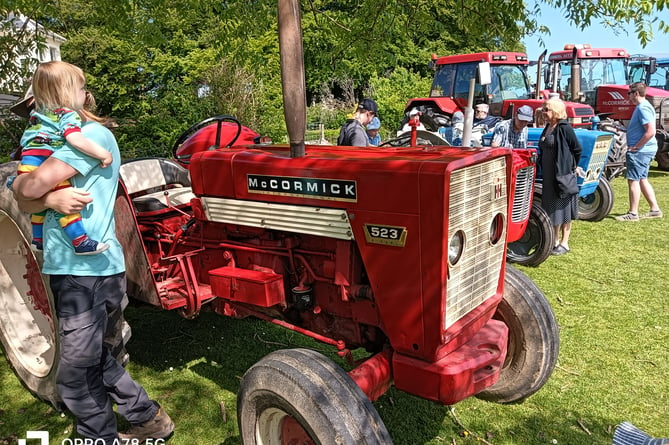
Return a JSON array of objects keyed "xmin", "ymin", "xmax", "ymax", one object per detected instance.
[{"xmin": 278, "ymin": 0, "xmax": 307, "ymax": 158}]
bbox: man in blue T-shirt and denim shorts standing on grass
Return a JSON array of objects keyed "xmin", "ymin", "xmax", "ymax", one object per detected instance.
[{"xmin": 616, "ymin": 82, "xmax": 662, "ymax": 221}]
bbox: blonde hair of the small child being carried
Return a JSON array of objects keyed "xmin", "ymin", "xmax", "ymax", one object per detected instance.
[{"xmin": 33, "ymin": 61, "xmax": 86, "ymax": 111}]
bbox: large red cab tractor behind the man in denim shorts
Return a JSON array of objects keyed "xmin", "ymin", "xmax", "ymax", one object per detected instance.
[{"xmin": 545, "ymin": 44, "xmax": 669, "ymax": 172}]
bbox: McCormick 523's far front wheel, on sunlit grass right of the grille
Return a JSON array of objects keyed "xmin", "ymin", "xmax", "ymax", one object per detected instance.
[{"xmin": 476, "ymin": 265, "xmax": 560, "ymax": 403}]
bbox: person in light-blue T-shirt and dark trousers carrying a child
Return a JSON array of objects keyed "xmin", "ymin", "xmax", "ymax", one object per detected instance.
[{"xmin": 11, "ymin": 106, "xmax": 174, "ymax": 445}]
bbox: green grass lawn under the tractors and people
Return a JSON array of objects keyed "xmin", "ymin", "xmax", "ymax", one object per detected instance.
[{"xmin": 0, "ymin": 165, "xmax": 669, "ymax": 445}]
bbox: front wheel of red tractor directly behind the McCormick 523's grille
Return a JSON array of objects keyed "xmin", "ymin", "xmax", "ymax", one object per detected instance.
[{"xmin": 506, "ymin": 201, "xmax": 555, "ymax": 267}]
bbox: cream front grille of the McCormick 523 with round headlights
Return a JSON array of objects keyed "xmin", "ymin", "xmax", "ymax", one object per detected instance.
[{"xmin": 444, "ymin": 158, "xmax": 508, "ymax": 329}]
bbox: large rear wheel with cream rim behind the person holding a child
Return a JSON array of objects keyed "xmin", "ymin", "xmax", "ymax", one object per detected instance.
[{"xmin": 0, "ymin": 162, "xmax": 60, "ymax": 406}]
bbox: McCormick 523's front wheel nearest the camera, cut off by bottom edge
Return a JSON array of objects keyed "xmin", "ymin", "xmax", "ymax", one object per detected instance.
[{"xmin": 237, "ymin": 349, "xmax": 392, "ymax": 445}]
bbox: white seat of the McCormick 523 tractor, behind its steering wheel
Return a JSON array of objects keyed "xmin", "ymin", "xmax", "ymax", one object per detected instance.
[{"xmin": 120, "ymin": 158, "xmax": 195, "ymax": 213}]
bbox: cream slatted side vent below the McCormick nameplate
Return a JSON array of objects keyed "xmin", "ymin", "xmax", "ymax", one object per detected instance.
[{"xmin": 202, "ymin": 197, "xmax": 353, "ymax": 240}]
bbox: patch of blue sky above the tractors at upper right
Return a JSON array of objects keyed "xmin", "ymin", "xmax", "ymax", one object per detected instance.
[{"xmin": 523, "ymin": 6, "xmax": 669, "ymax": 60}]
